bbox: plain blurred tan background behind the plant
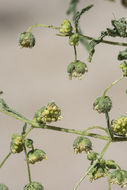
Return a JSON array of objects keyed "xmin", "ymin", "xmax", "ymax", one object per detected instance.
[{"xmin": 0, "ymin": 0, "xmax": 127, "ymax": 190}]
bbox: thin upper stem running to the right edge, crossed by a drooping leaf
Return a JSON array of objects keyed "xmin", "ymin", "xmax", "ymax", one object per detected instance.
[{"xmin": 79, "ymin": 34, "xmax": 127, "ymax": 46}]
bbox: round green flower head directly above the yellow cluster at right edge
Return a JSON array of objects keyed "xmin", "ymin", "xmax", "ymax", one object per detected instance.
[{"xmin": 93, "ymin": 96, "xmax": 112, "ymax": 113}]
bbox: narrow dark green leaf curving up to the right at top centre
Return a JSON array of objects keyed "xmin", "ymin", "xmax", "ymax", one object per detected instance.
[{"xmin": 74, "ymin": 5, "xmax": 93, "ymax": 32}]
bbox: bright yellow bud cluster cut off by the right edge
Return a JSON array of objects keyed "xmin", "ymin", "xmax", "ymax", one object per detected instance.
[{"xmin": 111, "ymin": 116, "xmax": 127, "ymax": 136}]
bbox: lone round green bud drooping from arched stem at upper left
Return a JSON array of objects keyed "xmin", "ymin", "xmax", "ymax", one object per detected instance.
[{"xmin": 19, "ymin": 32, "xmax": 35, "ymax": 48}]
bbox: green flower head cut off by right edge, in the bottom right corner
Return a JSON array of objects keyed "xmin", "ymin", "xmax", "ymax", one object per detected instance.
[{"xmin": 109, "ymin": 169, "xmax": 127, "ymax": 187}]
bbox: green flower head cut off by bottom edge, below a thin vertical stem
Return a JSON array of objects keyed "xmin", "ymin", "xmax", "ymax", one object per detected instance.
[{"xmin": 24, "ymin": 182, "xmax": 44, "ymax": 190}]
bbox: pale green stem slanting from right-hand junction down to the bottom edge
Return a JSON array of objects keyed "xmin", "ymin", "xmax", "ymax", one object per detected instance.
[{"xmin": 74, "ymin": 140, "xmax": 111, "ymax": 190}]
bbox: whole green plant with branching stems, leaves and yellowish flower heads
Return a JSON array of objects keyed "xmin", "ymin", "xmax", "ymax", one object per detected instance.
[{"xmin": 0, "ymin": 0, "xmax": 127, "ymax": 190}]
